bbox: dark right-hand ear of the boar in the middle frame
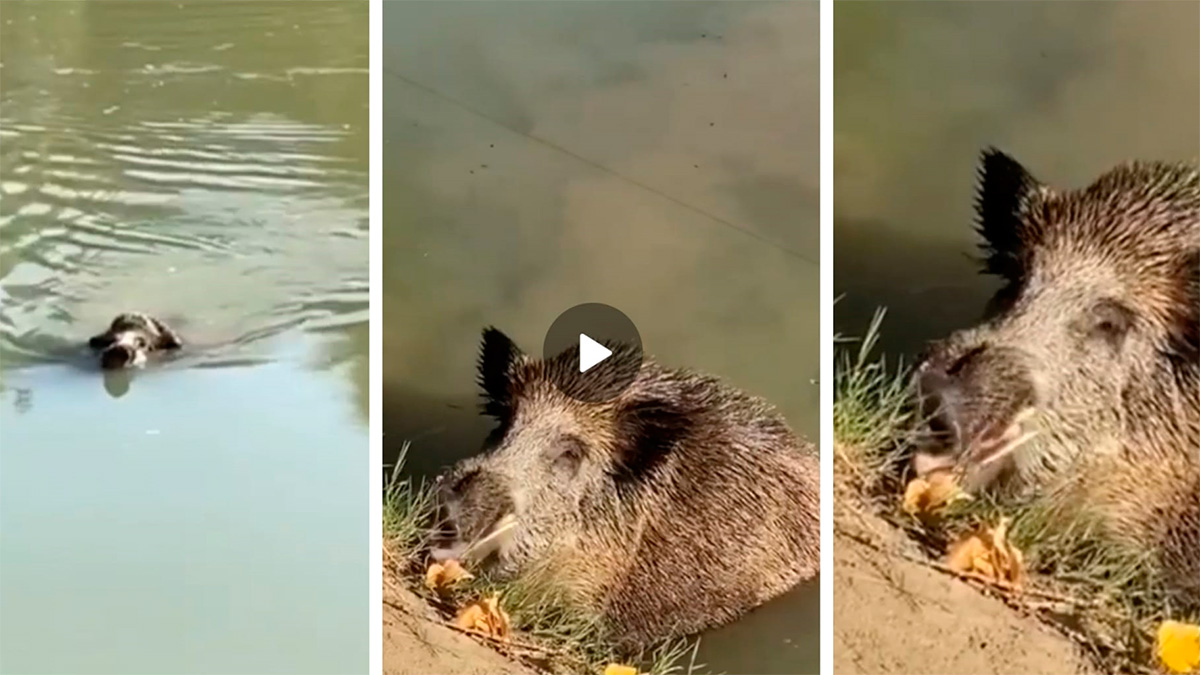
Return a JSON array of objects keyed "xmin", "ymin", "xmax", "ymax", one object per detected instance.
[{"xmin": 613, "ymin": 399, "xmax": 689, "ymax": 486}]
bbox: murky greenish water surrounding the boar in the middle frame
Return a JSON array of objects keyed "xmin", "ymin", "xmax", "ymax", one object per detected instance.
[{"xmin": 383, "ymin": 1, "xmax": 820, "ymax": 673}]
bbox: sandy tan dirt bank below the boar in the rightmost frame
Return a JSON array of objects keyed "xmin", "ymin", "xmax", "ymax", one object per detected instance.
[{"xmin": 833, "ymin": 508, "xmax": 1093, "ymax": 675}]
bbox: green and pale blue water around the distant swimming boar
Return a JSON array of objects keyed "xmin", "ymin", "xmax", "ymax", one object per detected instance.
[{"xmin": 0, "ymin": 1, "xmax": 370, "ymax": 674}]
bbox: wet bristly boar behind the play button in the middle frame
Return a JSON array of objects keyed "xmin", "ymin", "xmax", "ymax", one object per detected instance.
[{"xmin": 440, "ymin": 329, "xmax": 820, "ymax": 647}]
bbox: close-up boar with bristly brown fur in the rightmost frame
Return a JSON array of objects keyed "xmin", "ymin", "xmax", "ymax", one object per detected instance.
[{"xmin": 918, "ymin": 150, "xmax": 1200, "ymax": 611}]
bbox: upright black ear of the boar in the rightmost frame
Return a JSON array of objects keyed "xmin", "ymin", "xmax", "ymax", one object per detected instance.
[{"xmin": 976, "ymin": 148, "xmax": 1042, "ymax": 281}]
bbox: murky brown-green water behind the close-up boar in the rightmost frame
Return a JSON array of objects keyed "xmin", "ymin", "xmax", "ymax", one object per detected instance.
[{"xmin": 834, "ymin": 1, "xmax": 1200, "ymax": 353}]
